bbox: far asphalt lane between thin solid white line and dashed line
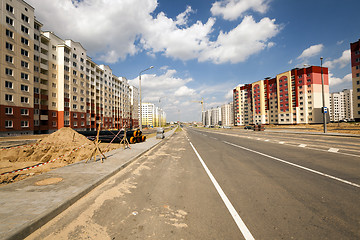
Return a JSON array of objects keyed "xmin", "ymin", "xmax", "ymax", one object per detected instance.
[{"xmin": 193, "ymin": 127, "xmax": 360, "ymax": 184}]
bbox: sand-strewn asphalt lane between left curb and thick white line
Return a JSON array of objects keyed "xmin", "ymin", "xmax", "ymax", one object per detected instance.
[{"xmin": 28, "ymin": 132, "xmax": 243, "ymax": 239}]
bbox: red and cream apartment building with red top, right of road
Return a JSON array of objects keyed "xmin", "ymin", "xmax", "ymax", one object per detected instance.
[{"xmin": 233, "ymin": 66, "xmax": 329, "ymax": 125}]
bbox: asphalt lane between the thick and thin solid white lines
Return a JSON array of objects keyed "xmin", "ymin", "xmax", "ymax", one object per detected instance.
[{"xmin": 189, "ymin": 128, "xmax": 360, "ymax": 239}]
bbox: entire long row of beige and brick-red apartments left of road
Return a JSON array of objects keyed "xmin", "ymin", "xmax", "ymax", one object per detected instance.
[{"xmin": 0, "ymin": 0, "xmax": 139, "ymax": 136}]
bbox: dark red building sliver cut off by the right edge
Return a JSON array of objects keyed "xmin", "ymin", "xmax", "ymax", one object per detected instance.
[{"xmin": 350, "ymin": 39, "xmax": 360, "ymax": 122}]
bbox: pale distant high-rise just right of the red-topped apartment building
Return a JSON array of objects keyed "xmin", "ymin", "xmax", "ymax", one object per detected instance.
[{"xmin": 329, "ymin": 89, "xmax": 354, "ymax": 122}]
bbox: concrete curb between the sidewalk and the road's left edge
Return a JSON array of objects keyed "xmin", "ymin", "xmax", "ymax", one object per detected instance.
[{"xmin": 5, "ymin": 128, "xmax": 176, "ymax": 240}]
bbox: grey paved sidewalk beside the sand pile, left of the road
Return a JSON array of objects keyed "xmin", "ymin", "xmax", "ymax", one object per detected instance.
[{"xmin": 0, "ymin": 129, "xmax": 175, "ymax": 239}]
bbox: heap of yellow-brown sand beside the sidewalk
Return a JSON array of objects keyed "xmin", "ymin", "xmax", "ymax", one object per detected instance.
[{"xmin": 0, "ymin": 128, "xmax": 119, "ymax": 184}]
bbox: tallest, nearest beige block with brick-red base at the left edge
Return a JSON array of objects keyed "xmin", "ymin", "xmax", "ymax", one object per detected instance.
[{"xmin": 0, "ymin": 0, "xmax": 35, "ymax": 134}]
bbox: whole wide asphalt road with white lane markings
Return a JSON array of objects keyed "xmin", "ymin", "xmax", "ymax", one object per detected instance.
[{"xmin": 28, "ymin": 128, "xmax": 360, "ymax": 239}]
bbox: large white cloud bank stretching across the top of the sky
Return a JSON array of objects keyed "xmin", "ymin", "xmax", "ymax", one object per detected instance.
[{"xmin": 28, "ymin": 0, "xmax": 280, "ymax": 64}]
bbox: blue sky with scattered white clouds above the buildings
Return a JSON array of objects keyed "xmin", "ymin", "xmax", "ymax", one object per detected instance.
[{"xmin": 26, "ymin": 0, "xmax": 360, "ymax": 121}]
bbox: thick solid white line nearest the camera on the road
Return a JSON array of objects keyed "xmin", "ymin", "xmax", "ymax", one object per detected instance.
[{"xmin": 190, "ymin": 142, "xmax": 255, "ymax": 240}]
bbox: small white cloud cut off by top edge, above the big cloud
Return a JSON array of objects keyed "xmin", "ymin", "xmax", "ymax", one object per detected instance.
[{"xmin": 211, "ymin": 0, "xmax": 269, "ymax": 20}]
